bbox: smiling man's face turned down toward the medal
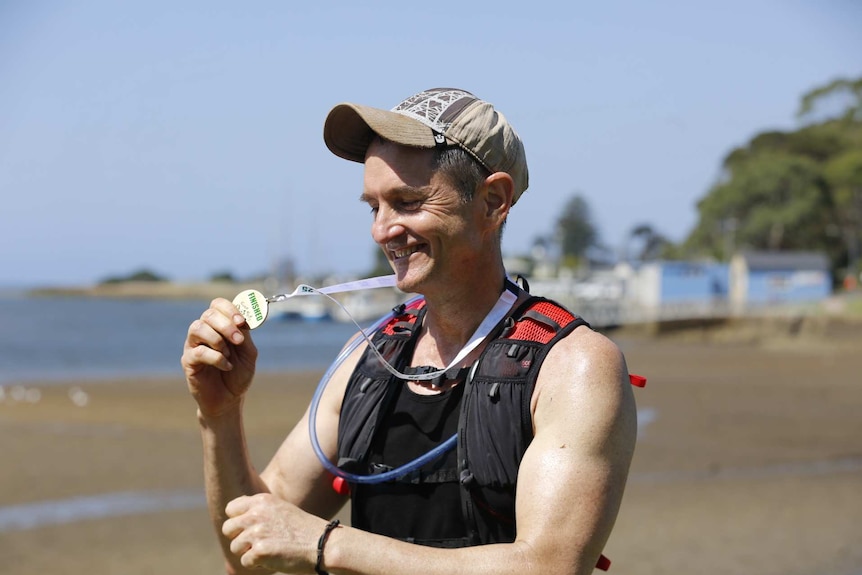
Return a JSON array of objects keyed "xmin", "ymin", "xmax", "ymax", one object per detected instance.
[{"xmin": 362, "ymin": 141, "xmax": 481, "ymax": 293}]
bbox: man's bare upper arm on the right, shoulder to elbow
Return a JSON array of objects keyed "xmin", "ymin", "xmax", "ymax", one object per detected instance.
[{"xmin": 516, "ymin": 333, "xmax": 637, "ymax": 572}]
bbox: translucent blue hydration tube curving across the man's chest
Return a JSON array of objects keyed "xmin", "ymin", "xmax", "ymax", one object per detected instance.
[{"xmin": 308, "ymin": 296, "xmax": 458, "ymax": 485}]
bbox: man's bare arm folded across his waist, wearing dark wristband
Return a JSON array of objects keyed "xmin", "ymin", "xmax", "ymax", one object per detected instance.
[{"xmin": 224, "ymin": 328, "xmax": 636, "ymax": 575}]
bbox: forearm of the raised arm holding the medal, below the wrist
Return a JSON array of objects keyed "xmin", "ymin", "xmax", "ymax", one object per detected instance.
[{"xmin": 198, "ymin": 406, "xmax": 269, "ymax": 573}]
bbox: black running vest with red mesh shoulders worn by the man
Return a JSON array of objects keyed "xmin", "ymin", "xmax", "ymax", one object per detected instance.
[{"xmin": 338, "ymin": 284, "xmax": 588, "ymax": 547}]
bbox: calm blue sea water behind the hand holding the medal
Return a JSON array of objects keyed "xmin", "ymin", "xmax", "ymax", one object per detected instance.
[{"xmin": 0, "ymin": 293, "xmax": 357, "ymax": 385}]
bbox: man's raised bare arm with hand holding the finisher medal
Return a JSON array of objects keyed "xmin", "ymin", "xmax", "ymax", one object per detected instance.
[{"xmin": 181, "ymin": 299, "xmax": 358, "ymax": 573}]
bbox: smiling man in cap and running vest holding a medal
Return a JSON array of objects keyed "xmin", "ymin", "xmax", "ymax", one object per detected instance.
[{"xmin": 182, "ymin": 89, "xmax": 636, "ymax": 575}]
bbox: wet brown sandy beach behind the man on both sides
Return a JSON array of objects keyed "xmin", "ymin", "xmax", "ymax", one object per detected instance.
[{"xmin": 0, "ymin": 324, "xmax": 862, "ymax": 575}]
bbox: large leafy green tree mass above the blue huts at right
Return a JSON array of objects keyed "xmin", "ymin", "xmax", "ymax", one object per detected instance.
[{"xmin": 685, "ymin": 78, "xmax": 862, "ymax": 280}]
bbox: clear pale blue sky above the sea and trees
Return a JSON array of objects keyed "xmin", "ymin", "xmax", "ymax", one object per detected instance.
[{"xmin": 0, "ymin": 0, "xmax": 862, "ymax": 286}]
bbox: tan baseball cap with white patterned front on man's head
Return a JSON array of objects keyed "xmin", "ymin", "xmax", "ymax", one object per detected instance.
[{"xmin": 323, "ymin": 88, "xmax": 529, "ymax": 203}]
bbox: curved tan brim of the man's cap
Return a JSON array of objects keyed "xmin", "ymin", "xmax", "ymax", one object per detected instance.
[{"xmin": 323, "ymin": 103, "xmax": 435, "ymax": 163}]
